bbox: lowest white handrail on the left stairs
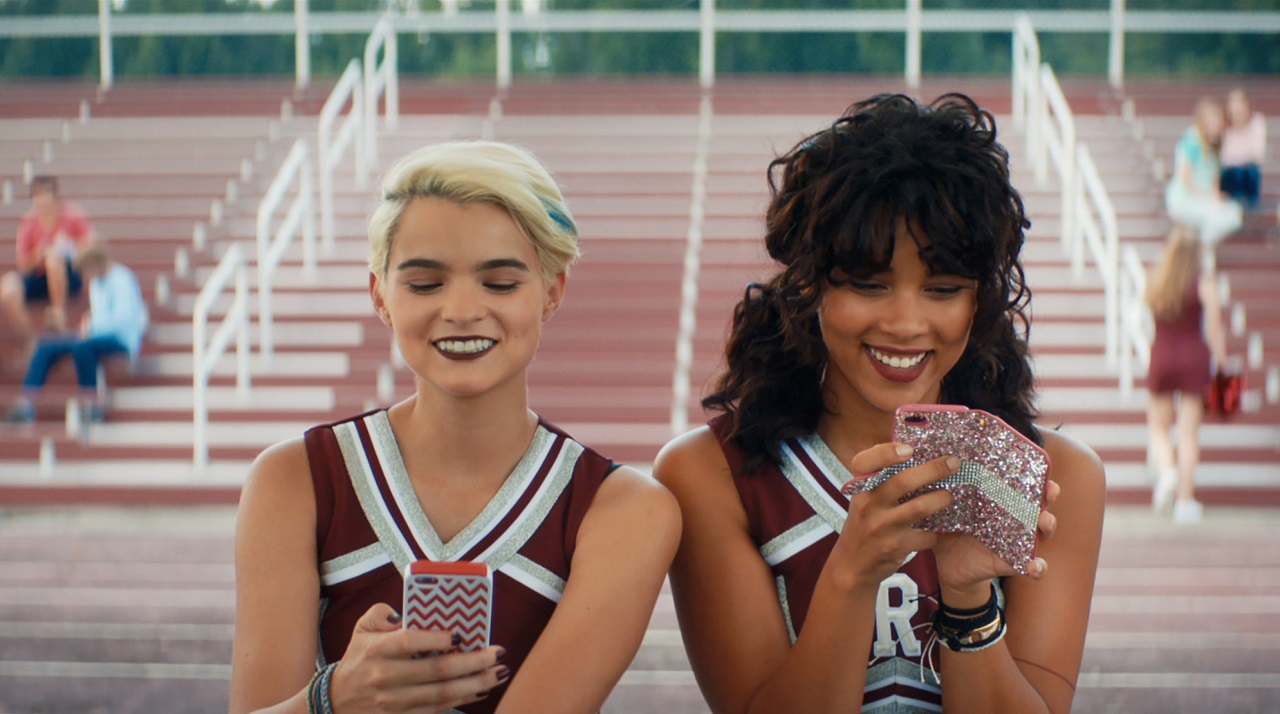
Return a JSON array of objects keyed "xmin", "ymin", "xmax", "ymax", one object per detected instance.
[{"xmin": 191, "ymin": 243, "xmax": 250, "ymax": 472}]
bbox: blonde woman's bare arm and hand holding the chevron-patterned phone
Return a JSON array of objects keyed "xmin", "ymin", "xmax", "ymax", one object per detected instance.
[{"xmin": 230, "ymin": 440, "xmax": 499, "ymax": 714}]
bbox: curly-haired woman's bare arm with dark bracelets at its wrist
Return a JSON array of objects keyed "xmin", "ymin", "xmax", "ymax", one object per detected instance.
[{"xmin": 940, "ymin": 431, "xmax": 1106, "ymax": 714}]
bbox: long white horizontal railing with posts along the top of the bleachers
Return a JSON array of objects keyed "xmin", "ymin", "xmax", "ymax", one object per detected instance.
[{"xmin": 24, "ymin": 0, "xmax": 1280, "ymax": 87}]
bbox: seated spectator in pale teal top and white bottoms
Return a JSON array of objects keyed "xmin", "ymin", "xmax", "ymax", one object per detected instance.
[{"xmin": 1165, "ymin": 100, "xmax": 1244, "ymax": 249}]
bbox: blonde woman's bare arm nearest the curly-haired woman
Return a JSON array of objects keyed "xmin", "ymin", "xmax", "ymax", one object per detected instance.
[{"xmin": 498, "ymin": 467, "xmax": 680, "ymax": 713}]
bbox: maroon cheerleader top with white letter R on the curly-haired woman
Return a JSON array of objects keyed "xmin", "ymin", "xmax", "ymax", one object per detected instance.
[{"xmin": 709, "ymin": 415, "xmax": 1000, "ymax": 714}]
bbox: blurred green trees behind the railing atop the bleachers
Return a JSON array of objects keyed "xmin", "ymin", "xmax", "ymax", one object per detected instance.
[{"xmin": 0, "ymin": 0, "xmax": 1280, "ymax": 79}]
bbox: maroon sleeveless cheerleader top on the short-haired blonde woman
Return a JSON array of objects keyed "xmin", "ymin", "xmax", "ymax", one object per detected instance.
[{"xmin": 305, "ymin": 409, "xmax": 614, "ymax": 713}]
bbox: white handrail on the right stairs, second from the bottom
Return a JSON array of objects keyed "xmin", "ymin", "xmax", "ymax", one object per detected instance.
[{"xmin": 1070, "ymin": 143, "xmax": 1120, "ymax": 367}]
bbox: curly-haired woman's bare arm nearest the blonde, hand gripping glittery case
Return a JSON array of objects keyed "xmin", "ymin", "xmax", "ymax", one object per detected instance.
[{"xmin": 654, "ymin": 429, "xmax": 950, "ymax": 713}]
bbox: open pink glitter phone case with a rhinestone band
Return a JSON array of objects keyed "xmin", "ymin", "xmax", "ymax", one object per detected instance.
[{"xmin": 842, "ymin": 404, "xmax": 1050, "ymax": 575}]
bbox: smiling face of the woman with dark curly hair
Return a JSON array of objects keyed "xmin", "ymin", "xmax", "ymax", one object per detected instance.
[{"xmin": 818, "ymin": 221, "xmax": 978, "ymax": 416}]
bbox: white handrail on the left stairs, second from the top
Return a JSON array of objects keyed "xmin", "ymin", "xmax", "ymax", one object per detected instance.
[{"xmin": 316, "ymin": 59, "xmax": 369, "ymax": 253}]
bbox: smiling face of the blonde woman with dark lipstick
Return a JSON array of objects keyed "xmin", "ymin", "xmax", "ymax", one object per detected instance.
[{"xmin": 370, "ymin": 197, "xmax": 564, "ymax": 398}]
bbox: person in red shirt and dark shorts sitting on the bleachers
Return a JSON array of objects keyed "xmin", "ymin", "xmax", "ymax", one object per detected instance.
[{"xmin": 0, "ymin": 177, "xmax": 93, "ymax": 339}]
